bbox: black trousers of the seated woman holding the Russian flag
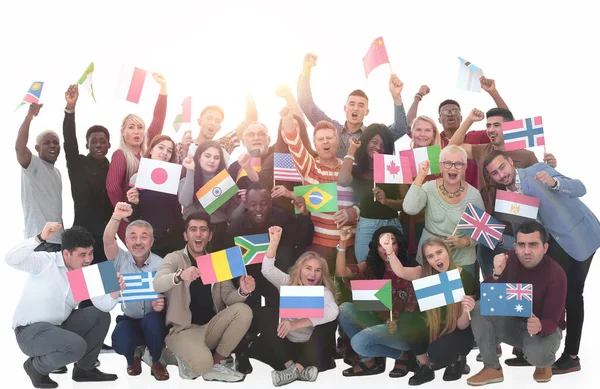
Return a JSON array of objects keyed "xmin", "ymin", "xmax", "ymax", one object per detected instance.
[{"xmin": 249, "ymin": 307, "xmax": 337, "ymax": 372}]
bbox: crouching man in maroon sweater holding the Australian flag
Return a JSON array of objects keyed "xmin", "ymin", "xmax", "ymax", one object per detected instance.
[{"xmin": 467, "ymin": 222, "xmax": 567, "ymax": 386}]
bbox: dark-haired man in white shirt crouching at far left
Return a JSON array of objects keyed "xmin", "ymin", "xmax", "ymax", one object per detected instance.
[{"xmin": 6, "ymin": 222, "xmax": 125, "ymax": 388}]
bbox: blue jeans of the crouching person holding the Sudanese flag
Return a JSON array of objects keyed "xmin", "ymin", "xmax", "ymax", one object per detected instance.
[{"xmin": 338, "ymin": 303, "xmax": 410, "ymax": 361}]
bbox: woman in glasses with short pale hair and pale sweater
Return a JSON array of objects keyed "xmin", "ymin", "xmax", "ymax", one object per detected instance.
[{"xmin": 402, "ymin": 145, "xmax": 484, "ymax": 274}]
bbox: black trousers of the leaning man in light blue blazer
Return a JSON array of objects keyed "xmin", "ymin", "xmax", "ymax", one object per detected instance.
[{"xmin": 547, "ymin": 237, "xmax": 594, "ymax": 355}]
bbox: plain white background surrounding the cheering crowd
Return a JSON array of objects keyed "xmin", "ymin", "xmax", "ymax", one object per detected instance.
[{"xmin": 0, "ymin": 0, "xmax": 600, "ymax": 388}]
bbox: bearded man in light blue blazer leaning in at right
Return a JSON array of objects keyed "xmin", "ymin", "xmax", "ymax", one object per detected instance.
[{"xmin": 483, "ymin": 150, "xmax": 600, "ymax": 374}]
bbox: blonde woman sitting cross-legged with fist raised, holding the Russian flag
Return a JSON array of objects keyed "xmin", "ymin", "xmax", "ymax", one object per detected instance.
[{"xmin": 250, "ymin": 226, "xmax": 339, "ymax": 386}]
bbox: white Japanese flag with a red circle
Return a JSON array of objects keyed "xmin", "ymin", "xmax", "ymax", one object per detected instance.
[{"xmin": 135, "ymin": 158, "xmax": 181, "ymax": 195}]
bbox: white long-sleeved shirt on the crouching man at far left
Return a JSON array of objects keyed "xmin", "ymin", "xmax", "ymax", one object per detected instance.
[{"xmin": 6, "ymin": 238, "xmax": 117, "ymax": 329}]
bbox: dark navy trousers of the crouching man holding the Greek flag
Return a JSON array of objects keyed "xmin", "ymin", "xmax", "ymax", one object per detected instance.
[{"xmin": 112, "ymin": 312, "xmax": 166, "ymax": 366}]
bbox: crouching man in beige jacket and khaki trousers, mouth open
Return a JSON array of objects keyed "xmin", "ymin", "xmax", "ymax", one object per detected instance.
[{"xmin": 154, "ymin": 213, "xmax": 254, "ymax": 382}]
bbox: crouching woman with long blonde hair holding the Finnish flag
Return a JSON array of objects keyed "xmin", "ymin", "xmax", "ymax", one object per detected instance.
[{"xmin": 390, "ymin": 236, "xmax": 476, "ymax": 385}]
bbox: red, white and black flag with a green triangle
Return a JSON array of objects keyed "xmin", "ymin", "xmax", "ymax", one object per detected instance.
[{"xmin": 350, "ymin": 280, "xmax": 392, "ymax": 311}]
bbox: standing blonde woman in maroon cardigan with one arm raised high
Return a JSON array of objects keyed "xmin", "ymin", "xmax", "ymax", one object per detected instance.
[{"xmin": 106, "ymin": 73, "xmax": 167, "ymax": 242}]
